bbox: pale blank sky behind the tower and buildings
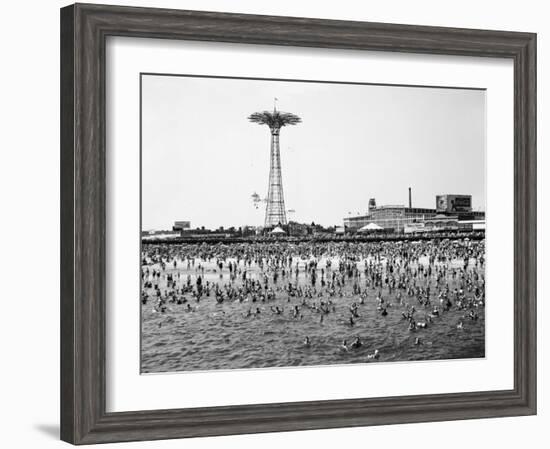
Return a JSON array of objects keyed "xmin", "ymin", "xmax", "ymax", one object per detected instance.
[{"xmin": 142, "ymin": 75, "xmax": 486, "ymax": 230}]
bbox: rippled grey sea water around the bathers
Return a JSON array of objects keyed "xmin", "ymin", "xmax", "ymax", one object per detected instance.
[{"xmin": 141, "ymin": 247, "xmax": 485, "ymax": 373}]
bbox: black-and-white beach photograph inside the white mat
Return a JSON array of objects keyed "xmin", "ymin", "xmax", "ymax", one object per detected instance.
[{"xmin": 139, "ymin": 73, "xmax": 486, "ymax": 373}]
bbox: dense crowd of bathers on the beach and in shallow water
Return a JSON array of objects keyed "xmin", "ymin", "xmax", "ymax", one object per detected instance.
[{"xmin": 141, "ymin": 238, "xmax": 485, "ymax": 360}]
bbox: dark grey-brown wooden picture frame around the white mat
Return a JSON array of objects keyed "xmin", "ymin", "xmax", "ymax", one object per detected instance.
[{"xmin": 61, "ymin": 4, "xmax": 536, "ymax": 444}]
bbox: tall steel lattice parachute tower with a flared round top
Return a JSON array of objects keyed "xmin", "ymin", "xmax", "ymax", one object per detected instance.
[{"xmin": 248, "ymin": 107, "xmax": 302, "ymax": 228}]
